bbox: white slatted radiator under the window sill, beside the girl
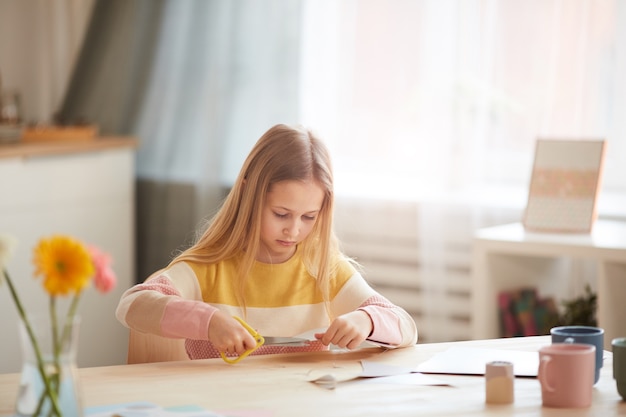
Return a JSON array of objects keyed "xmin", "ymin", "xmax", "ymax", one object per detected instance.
[{"xmin": 335, "ymin": 198, "xmax": 520, "ymax": 342}]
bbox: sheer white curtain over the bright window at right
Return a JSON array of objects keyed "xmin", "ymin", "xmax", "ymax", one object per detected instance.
[{"xmin": 300, "ymin": 0, "xmax": 626, "ymax": 341}]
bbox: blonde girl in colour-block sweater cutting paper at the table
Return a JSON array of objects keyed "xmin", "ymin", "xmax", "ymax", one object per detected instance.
[{"xmin": 116, "ymin": 125, "xmax": 417, "ymax": 359}]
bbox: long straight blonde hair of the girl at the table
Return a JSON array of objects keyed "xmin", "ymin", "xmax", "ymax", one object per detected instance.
[{"xmin": 170, "ymin": 124, "xmax": 343, "ymax": 310}]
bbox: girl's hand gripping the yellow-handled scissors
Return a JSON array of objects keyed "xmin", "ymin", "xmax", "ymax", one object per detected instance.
[{"xmin": 208, "ymin": 311, "xmax": 256, "ymax": 355}]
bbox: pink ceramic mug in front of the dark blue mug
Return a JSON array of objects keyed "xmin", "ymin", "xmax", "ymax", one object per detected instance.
[{"xmin": 537, "ymin": 343, "xmax": 596, "ymax": 408}]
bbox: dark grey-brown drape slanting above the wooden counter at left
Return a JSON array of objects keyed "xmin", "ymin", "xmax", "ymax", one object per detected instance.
[{"xmin": 59, "ymin": 0, "xmax": 165, "ymax": 131}]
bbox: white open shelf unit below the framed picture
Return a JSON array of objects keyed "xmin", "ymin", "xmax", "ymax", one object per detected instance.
[{"xmin": 472, "ymin": 220, "xmax": 626, "ymax": 348}]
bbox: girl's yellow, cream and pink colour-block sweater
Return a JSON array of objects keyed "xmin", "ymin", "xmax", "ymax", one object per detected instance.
[{"xmin": 116, "ymin": 247, "xmax": 417, "ymax": 359}]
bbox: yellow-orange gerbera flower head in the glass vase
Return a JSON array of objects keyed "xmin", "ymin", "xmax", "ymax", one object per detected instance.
[{"xmin": 33, "ymin": 236, "xmax": 95, "ymax": 296}]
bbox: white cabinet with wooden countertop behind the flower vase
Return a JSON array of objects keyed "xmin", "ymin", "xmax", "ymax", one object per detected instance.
[{"xmin": 0, "ymin": 138, "xmax": 135, "ymax": 373}]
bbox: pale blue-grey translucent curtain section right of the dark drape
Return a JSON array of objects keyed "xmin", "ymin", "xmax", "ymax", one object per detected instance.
[{"xmin": 135, "ymin": 0, "xmax": 299, "ymax": 202}]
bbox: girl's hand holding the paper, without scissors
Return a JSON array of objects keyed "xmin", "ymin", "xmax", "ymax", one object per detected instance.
[{"xmin": 315, "ymin": 310, "xmax": 374, "ymax": 349}]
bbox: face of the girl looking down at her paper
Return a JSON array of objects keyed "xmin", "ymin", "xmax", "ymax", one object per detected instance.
[{"xmin": 256, "ymin": 180, "xmax": 324, "ymax": 264}]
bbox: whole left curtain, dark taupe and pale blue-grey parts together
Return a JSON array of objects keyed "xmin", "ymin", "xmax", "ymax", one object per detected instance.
[{"xmin": 59, "ymin": 0, "xmax": 301, "ymax": 281}]
